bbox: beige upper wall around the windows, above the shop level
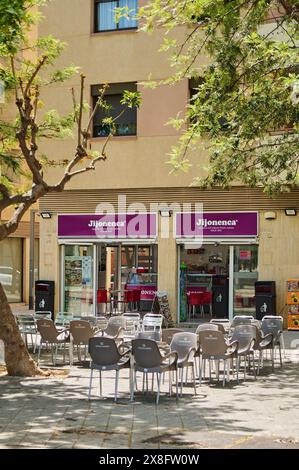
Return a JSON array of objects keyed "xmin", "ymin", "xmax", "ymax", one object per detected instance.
[{"xmin": 39, "ymin": 0, "xmax": 210, "ymax": 189}]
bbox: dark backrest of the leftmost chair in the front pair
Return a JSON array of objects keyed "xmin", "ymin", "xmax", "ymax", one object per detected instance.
[{"xmin": 88, "ymin": 336, "xmax": 121, "ymax": 366}]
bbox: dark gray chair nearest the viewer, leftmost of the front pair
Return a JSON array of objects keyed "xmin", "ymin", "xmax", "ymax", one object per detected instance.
[{"xmin": 88, "ymin": 336, "xmax": 130, "ymax": 401}]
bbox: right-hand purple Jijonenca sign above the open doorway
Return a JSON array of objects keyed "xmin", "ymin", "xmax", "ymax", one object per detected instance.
[{"xmin": 176, "ymin": 212, "xmax": 258, "ymax": 238}]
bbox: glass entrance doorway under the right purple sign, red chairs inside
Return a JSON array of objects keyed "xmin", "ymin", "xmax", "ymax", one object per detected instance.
[{"xmin": 179, "ymin": 242, "xmax": 258, "ymax": 321}]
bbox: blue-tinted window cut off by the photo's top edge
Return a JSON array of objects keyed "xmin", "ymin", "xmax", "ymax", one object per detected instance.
[{"xmin": 95, "ymin": 0, "xmax": 137, "ymax": 32}]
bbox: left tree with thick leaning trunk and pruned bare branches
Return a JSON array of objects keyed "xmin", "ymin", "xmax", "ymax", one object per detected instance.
[{"xmin": 0, "ymin": 0, "xmax": 139, "ymax": 376}]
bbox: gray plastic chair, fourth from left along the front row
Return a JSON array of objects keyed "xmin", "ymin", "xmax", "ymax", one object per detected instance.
[{"xmin": 199, "ymin": 330, "xmax": 239, "ymax": 386}]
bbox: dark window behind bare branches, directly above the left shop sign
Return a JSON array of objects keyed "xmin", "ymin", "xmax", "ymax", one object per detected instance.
[{"xmin": 91, "ymin": 83, "xmax": 137, "ymax": 137}]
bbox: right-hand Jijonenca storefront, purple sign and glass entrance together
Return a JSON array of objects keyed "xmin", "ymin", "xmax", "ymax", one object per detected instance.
[{"xmin": 175, "ymin": 212, "xmax": 258, "ymax": 321}]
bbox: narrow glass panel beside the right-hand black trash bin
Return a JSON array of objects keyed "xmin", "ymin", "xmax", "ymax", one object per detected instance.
[{"xmin": 232, "ymin": 245, "xmax": 258, "ymax": 316}]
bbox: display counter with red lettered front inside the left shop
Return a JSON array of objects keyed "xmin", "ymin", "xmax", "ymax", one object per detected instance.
[{"xmin": 125, "ymin": 269, "xmax": 158, "ymax": 311}]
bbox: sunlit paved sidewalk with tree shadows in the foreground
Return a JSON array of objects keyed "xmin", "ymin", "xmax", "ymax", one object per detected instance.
[{"xmin": 0, "ymin": 351, "xmax": 299, "ymax": 449}]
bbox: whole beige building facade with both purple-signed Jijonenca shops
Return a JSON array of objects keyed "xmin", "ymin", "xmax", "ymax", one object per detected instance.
[{"xmin": 39, "ymin": 0, "xmax": 299, "ymax": 322}]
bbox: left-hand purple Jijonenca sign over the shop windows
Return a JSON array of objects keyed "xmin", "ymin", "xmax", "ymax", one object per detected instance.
[{"xmin": 58, "ymin": 213, "xmax": 157, "ymax": 238}]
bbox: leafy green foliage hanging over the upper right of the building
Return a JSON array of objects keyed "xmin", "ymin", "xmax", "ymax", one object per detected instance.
[{"xmin": 140, "ymin": 0, "xmax": 299, "ymax": 194}]
